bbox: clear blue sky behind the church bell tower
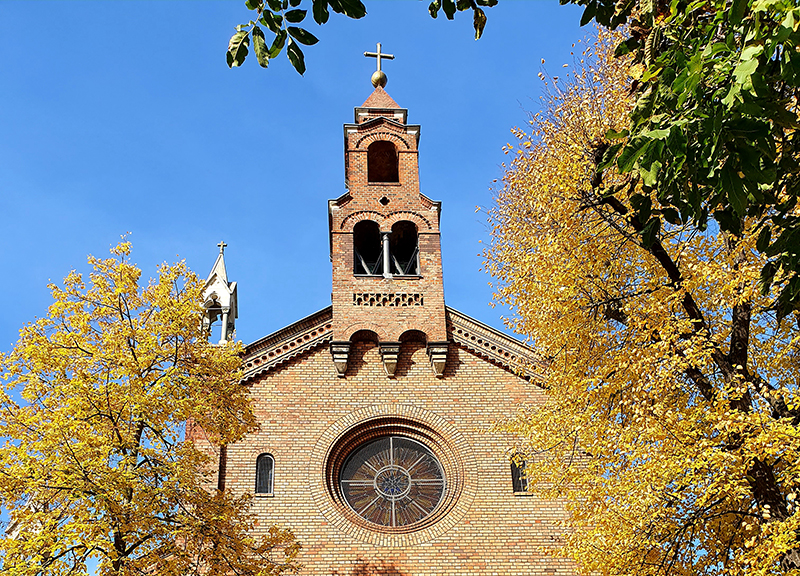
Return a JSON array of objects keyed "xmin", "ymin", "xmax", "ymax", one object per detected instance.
[{"xmin": 0, "ymin": 0, "xmax": 591, "ymax": 351}]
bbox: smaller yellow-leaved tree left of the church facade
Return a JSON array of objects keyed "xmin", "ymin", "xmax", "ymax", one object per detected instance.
[{"xmin": 0, "ymin": 242, "xmax": 299, "ymax": 576}]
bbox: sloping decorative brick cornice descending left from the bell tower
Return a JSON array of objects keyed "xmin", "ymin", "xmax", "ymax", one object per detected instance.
[{"xmin": 242, "ymin": 306, "xmax": 333, "ymax": 382}]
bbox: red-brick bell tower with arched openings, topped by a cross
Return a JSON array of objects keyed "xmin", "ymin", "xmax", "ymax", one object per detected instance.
[{"xmin": 328, "ymin": 44, "xmax": 448, "ymax": 377}]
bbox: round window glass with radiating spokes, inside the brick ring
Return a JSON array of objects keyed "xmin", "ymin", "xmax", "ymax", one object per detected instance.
[{"xmin": 339, "ymin": 436, "xmax": 445, "ymax": 528}]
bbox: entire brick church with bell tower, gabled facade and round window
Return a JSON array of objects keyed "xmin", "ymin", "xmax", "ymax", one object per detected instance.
[{"xmin": 199, "ymin": 51, "xmax": 573, "ymax": 576}]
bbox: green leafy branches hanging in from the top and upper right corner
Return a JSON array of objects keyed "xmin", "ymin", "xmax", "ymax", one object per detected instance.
[{"xmin": 227, "ymin": 0, "xmax": 800, "ymax": 322}]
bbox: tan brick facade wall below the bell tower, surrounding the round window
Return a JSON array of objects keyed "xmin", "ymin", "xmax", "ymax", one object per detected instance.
[{"xmin": 226, "ymin": 341, "xmax": 573, "ymax": 576}]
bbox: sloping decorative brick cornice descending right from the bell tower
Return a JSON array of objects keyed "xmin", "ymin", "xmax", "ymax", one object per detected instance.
[{"xmin": 445, "ymin": 306, "xmax": 547, "ymax": 382}]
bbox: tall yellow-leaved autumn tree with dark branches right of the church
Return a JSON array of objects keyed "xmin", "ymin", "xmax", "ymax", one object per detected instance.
[{"xmin": 487, "ymin": 33, "xmax": 800, "ymax": 575}]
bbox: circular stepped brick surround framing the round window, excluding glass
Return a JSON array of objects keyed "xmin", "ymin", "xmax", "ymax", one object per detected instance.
[{"xmin": 309, "ymin": 404, "xmax": 478, "ymax": 547}]
